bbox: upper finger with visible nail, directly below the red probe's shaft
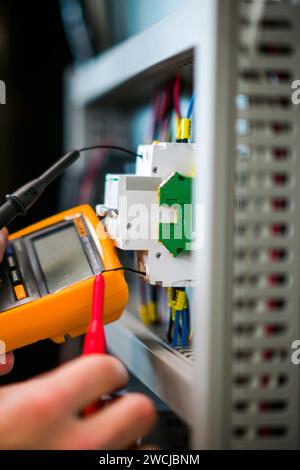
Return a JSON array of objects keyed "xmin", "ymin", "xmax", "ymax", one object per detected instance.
[{"xmin": 38, "ymin": 355, "xmax": 128, "ymax": 413}]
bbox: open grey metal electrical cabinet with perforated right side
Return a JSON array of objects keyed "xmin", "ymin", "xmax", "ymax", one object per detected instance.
[{"xmin": 65, "ymin": 0, "xmax": 300, "ymax": 449}]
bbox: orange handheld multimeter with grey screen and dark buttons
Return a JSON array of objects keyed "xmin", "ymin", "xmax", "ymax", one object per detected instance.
[{"xmin": 0, "ymin": 205, "xmax": 128, "ymax": 351}]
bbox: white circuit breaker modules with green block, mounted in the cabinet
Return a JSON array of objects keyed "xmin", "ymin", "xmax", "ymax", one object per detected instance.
[{"xmin": 100, "ymin": 143, "xmax": 195, "ymax": 287}]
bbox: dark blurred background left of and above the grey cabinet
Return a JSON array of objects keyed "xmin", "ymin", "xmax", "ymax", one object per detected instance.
[{"xmin": 0, "ymin": 0, "xmax": 188, "ymax": 383}]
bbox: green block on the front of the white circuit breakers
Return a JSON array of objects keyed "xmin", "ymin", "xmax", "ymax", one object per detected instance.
[{"xmin": 159, "ymin": 173, "xmax": 193, "ymax": 256}]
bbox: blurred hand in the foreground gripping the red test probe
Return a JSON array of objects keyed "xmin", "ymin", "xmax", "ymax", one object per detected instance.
[{"xmin": 0, "ymin": 355, "xmax": 155, "ymax": 450}]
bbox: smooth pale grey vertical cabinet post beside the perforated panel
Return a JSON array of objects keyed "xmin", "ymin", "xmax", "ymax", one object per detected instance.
[{"xmin": 193, "ymin": 1, "xmax": 237, "ymax": 449}]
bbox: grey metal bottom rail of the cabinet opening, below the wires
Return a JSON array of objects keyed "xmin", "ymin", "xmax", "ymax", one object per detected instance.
[{"xmin": 106, "ymin": 312, "xmax": 194, "ymax": 425}]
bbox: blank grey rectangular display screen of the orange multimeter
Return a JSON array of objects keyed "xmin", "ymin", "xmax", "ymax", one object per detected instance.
[{"xmin": 33, "ymin": 224, "xmax": 93, "ymax": 293}]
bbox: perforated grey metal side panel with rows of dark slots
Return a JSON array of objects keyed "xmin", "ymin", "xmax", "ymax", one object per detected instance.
[{"xmin": 228, "ymin": 1, "xmax": 300, "ymax": 449}]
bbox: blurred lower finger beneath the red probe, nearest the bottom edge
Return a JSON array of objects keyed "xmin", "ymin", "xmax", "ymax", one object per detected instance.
[{"xmin": 81, "ymin": 394, "xmax": 156, "ymax": 450}]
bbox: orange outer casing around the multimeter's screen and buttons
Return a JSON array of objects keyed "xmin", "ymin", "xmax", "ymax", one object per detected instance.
[{"xmin": 0, "ymin": 205, "xmax": 128, "ymax": 352}]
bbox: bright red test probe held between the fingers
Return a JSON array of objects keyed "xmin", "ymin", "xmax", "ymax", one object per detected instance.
[{"xmin": 82, "ymin": 273, "xmax": 106, "ymax": 416}]
